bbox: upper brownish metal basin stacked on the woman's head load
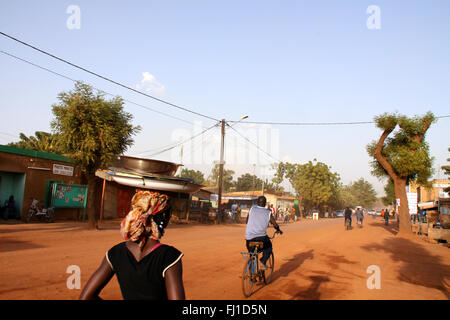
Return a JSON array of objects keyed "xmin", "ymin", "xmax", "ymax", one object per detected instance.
[{"xmin": 114, "ymin": 156, "xmax": 182, "ymax": 176}]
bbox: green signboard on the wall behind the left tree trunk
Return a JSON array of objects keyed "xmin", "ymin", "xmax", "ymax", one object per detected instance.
[{"xmin": 52, "ymin": 183, "xmax": 88, "ymax": 208}]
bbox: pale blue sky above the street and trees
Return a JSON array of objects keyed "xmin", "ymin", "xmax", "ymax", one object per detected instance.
[{"xmin": 0, "ymin": 0, "xmax": 450, "ymax": 196}]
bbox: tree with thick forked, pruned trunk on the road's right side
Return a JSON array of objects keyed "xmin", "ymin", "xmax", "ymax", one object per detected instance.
[{"xmin": 367, "ymin": 112, "xmax": 435, "ymax": 235}]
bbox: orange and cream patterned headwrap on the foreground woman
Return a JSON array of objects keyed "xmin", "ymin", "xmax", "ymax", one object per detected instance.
[{"xmin": 120, "ymin": 190, "xmax": 170, "ymax": 250}]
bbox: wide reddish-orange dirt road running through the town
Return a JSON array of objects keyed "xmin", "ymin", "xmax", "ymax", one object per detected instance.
[{"xmin": 0, "ymin": 217, "xmax": 450, "ymax": 300}]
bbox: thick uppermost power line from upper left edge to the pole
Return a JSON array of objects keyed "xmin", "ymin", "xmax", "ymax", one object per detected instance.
[{"xmin": 0, "ymin": 31, "xmax": 219, "ymax": 121}]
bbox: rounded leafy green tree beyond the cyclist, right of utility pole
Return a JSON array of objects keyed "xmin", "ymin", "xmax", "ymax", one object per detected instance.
[{"xmin": 275, "ymin": 159, "xmax": 340, "ymax": 215}]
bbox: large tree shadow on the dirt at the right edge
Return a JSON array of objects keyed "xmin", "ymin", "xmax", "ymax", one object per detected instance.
[{"xmin": 361, "ymin": 236, "xmax": 450, "ymax": 299}]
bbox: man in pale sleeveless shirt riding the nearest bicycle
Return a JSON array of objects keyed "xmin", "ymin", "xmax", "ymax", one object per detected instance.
[{"xmin": 245, "ymin": 196, "xmax": 283, "ymax": 270}]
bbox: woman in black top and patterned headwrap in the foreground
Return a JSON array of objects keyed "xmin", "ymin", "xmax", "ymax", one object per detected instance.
[{"xmin": 80, "ymin": 191, "xmax": 185, "ymax": 300}]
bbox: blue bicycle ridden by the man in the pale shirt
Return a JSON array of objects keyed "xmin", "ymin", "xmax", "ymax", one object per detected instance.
[{"xmin": 241, "ymin": 231, "xmax": 280, "ymax": 298}]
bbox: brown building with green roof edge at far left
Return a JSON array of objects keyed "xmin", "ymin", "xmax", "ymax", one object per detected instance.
[{"xmin": 0, "ymin": 145, "xmax": 82, "ymax": 220}]
